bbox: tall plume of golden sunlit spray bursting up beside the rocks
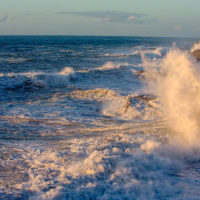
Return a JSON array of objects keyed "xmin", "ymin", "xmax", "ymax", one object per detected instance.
[{"xmin": 143, "ymin": 49, "xmax": 200, "ymax": 148}]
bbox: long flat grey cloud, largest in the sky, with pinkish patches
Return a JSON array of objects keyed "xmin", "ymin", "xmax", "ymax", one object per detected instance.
[{"xmin": 57, "ymin": 11, "xmax": 155, "ymax": 23}]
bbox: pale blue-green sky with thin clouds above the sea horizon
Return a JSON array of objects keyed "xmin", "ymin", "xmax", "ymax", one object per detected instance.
[{"xmin": 0, "ymin": 0, "xmax": 200, "ymax": 37}]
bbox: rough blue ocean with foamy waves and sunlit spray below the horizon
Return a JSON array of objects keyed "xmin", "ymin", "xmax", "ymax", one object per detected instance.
[{"xmin": 0, "ymin": 36, "xmax": 200, "ymax": 200}]
